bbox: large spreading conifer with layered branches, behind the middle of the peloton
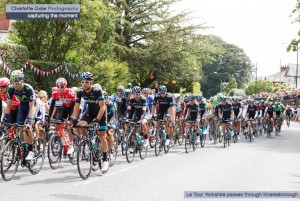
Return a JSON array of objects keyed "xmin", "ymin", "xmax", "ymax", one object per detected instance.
[{"xmin": 111, "ymin": 0, "xmax": 209, "ymax": 91}]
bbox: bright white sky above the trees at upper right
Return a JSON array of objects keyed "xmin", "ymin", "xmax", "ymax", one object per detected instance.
[{"xmin": 171, "ymin": 0, "xmax": 300, "ymax": 77}]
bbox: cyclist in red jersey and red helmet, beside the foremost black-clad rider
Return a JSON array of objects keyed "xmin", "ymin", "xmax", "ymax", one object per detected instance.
[{"xmin": 47, "ymin": 78, "xmax": 76, "ymax": 154}]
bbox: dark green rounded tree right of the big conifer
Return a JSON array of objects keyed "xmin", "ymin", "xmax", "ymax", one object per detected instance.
[{"xmin": 201, "ymin": 36, "xmax": 253, "ymax": 97}]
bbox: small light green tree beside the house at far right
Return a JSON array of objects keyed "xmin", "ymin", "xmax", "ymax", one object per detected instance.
[{"xmin": 245, "ymin": 80, "xmax": 274, "ymax": 95}]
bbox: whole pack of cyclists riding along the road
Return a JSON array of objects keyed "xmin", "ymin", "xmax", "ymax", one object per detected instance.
[{"xmin": 0, "ymin": 70, "xmax": 292, "ymax": 181}]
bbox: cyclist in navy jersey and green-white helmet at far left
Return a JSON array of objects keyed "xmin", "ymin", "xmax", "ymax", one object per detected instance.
[{"xmin": 3, "ymin": 70, "xmax": 36, "ymax": 160}]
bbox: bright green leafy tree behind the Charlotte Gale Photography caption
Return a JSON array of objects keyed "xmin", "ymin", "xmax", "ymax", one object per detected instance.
[{"xmin": 9, "ymin": 0, "xmax": 115, "ymax": 65}]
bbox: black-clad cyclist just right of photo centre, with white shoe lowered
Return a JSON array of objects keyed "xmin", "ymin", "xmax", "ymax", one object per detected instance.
[{"xmin": 152, "ymin": 85, "xmax": 175, "ymax": 146}]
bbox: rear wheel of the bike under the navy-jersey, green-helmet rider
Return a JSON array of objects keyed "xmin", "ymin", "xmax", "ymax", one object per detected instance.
[{"xmin": 28, "ymin": 137, "xmax": 46, "ymax": 175}]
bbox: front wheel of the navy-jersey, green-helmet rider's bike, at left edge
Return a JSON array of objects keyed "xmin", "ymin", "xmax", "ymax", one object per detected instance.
[{"xmin": 1, "ymin": 140, "xmax": 22, "ymax": 181}]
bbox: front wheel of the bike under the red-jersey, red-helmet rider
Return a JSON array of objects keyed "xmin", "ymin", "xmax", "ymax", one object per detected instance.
[{"xmin": 47, "ymin": 133, "xmax": 63, "ymax": 170}]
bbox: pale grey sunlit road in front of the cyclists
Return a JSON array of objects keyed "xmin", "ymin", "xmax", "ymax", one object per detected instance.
[{"xmin": 0, "ymin": 122, "xmax": 300, "ymax": 201}]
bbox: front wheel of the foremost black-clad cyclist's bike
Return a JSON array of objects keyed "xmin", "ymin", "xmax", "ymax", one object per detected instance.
[{"xmin": 77, "ymin": 139, "xmax": 93, "ymax": 180}]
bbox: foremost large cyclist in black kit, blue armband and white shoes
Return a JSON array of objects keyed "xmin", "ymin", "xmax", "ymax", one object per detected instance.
[{"xmin": 72, "ymin": 72, "xmax": 109, "ymax": 171}]
